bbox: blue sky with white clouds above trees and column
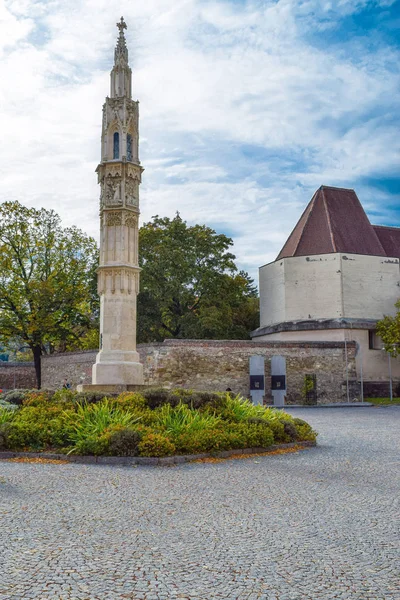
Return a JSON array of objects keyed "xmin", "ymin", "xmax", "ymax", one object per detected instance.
[{"xmin": 0, "ymin": 0, "xmax": 400, "ymax": 280}]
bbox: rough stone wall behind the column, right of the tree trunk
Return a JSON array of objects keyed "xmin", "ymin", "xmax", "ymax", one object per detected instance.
[{"xmin": 42, "ymin": 340, "xmax": 359, "ymax": 404}]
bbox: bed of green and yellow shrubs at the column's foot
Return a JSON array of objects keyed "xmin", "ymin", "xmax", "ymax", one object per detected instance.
[{"xmin": 0, "ymin": 389, "xmax": 317, "ymax": 457}]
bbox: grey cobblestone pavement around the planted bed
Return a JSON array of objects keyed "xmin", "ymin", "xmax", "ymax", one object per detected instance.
[{"xmin": 0, "ymin": 407, "xmax": 400, "ymax": 600}]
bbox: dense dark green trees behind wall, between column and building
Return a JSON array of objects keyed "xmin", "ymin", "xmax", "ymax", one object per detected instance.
[{"xmin": 138, "ymin": 213, "xmax": 258, "ymax": 342}]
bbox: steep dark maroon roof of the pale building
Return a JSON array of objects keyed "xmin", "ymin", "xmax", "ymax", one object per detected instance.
[{"xmin": 277, "ymin": 185, "xmax": 400, "ymax": 260}]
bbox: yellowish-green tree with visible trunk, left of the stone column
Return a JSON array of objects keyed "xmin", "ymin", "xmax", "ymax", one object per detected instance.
[{"xmin": 0, "ymin": 202, "xmax": 98, "ymax": 388}]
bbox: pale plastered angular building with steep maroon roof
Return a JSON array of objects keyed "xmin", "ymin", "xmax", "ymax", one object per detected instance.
[{"xmin": 252, "ymin": 186, "xmax": 400, "ymax": 381}]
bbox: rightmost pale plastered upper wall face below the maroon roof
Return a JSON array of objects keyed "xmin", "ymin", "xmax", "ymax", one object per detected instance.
[{"xmin": 341, "ymin": 254, "xmax": 400, "ymax": 319}]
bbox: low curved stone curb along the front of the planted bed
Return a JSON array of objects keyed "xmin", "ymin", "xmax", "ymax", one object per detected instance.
[{"xmin": 0, "ymin": 442, "xmax": 317, "ymax": 467}]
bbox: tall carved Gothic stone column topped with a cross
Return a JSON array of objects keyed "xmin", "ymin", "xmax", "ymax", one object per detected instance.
[{"xmin": 79, "ymin": 17, "xmax": 143, "ymax": 391}]
